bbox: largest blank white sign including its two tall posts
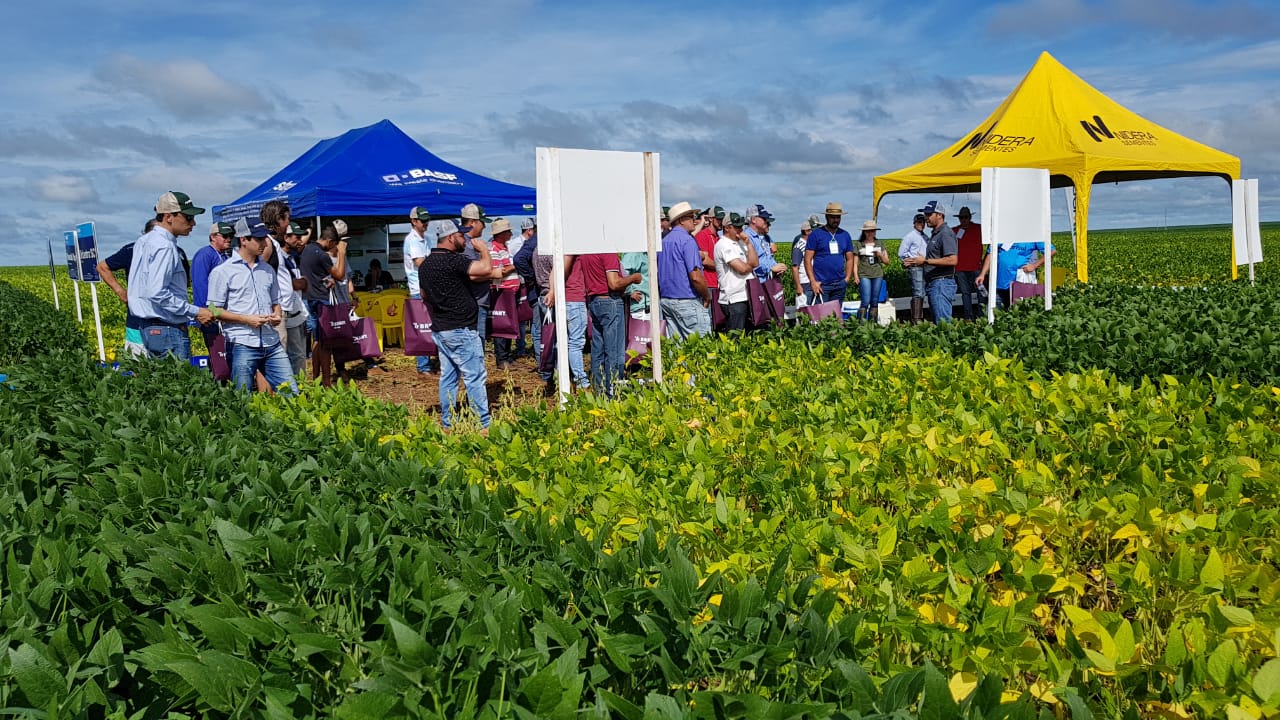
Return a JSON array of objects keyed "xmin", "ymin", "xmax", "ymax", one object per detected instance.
[{"xmin": 536, "ymin": 147, "xmax": 662, "ymax": 404}]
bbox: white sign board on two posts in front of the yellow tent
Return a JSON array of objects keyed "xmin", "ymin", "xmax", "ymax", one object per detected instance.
[{"xmin": 982, "ymin": 168, "xmax": 1053, "ymax": 323}]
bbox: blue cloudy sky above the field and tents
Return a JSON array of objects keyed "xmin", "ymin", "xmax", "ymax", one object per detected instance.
[{"xmin": 0, "ymin": 0, "xmax": 1280, "ymax": 265}]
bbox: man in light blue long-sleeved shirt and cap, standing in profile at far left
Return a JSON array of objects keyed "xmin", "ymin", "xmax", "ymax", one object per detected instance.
[{"xmin": 128, "ymin": 191, "xmax": 212, "ymax": 360}]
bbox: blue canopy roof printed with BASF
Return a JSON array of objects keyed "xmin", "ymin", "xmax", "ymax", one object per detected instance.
[{"xmin": 214, "ymin": 120, "xmax": 536, "ymax": 222}]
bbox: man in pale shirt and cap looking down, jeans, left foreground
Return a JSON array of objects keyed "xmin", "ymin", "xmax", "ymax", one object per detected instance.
[{"xmin": 209, "ymin": 220, "xmax": 298, "ymax": 393}]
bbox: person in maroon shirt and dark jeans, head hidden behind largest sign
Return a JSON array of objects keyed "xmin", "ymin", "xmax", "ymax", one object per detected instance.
[{"xmin": 577, "ymin": 252, "xmax": 640, "ymax": 397}]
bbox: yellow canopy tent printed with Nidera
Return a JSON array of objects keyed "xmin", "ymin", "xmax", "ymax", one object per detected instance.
[{"xmin": 873, "ymin": 53, "xmax": 1240, "ymax": 282}]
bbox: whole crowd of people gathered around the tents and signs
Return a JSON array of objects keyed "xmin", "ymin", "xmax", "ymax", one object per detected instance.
[{"xmin": 107, "ymin": 191, "xmax": 1052, "ymax": 429}]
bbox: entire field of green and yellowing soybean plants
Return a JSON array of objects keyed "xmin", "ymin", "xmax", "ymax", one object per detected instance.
[{"xmin": 0, "ymin": 222, "xmax": 1280, "ymax": 719}]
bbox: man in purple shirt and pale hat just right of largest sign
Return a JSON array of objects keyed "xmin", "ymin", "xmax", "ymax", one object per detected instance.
[{"xmin": 658, "ymin": 202, "xmax": 712, "ymax": 338}]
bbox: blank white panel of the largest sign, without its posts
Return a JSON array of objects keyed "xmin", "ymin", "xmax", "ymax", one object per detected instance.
[{"xmin": 538, "ymin": 147, "xmax": 662, "ymax": 255}]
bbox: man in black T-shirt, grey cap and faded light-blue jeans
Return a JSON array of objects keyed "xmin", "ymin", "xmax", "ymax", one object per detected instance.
[{"xmin": 419, "ymin": 220, "xmax": 493, "ymax": 434}]
